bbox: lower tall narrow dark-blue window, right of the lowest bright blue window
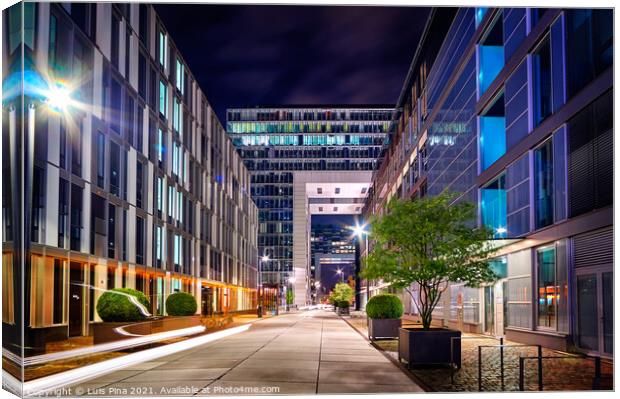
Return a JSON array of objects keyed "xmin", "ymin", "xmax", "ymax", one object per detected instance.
[{"xmin": 534, "ymin": 140, "xmax": 553, "ymax": 229}]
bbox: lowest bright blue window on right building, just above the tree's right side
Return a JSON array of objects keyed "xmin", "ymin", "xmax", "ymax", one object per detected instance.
[{"xmin": 480, "ymin": 174, "xmax": 507, "ymax": 238}]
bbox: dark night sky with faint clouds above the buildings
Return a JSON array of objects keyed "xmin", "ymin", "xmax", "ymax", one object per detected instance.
[{"xmin": 155, "ymin": 4, "xmax": 429, "ymax": 123}]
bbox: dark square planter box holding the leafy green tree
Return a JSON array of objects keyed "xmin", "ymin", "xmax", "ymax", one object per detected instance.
[{"xmin": 398, "ymin": 327, "xmax": 461, "ymax": 368}]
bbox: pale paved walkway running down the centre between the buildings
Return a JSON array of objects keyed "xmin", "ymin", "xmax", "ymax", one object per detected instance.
[{"xmin": 71, "ymin": 310, "xmax": 422, "ymax": 396}]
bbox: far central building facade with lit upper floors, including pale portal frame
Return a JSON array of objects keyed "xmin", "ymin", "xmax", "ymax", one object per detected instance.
[{"xmin": 226, "ymin": 105, "xmax": 393, "ymax": 305}]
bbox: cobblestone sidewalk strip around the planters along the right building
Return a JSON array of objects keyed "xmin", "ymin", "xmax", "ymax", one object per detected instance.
[{"xmin": 348, "ymin": 312, "xmax": 613, "ymax": 392}]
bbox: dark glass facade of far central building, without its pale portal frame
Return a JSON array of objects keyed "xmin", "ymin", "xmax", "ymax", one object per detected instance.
[{"xmin": 226, "ymin": 106, "xmax": 393, "ymax": 290}]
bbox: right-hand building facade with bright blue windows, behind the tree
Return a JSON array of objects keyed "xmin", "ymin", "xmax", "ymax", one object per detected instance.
[{"xmin": 366, "ymin": 8, "xmax": 613, "ymax": 356}]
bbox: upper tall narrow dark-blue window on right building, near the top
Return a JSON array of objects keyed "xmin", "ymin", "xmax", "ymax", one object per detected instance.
[{"xmin": 532, "ymin": 36, "xmax": 552, "ymax": 126}]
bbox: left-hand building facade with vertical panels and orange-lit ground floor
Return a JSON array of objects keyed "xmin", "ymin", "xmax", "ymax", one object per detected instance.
[{"xmin": 2, "ymin": 3, "xmax": 258, "ymax": 352}]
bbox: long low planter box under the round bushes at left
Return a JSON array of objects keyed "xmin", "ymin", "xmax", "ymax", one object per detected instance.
[{"xmin": 91, "ymin": 315, "xmax": 201, "ymax": 345}]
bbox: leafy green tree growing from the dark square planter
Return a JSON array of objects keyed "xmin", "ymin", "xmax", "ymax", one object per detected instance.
[{"xmin": 361, "ymin": 193, "xmax": 497, "ymax": 329}]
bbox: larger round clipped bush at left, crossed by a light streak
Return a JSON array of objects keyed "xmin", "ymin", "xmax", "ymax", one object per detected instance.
[{"xmin": 97, "ymin": 288, "xmax": 151, "ymax": 321}]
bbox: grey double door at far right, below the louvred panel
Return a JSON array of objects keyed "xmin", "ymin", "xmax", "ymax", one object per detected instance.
[{"xmin": 575, "ymin": 268, "xmax": 614, "ymax": 356}]
